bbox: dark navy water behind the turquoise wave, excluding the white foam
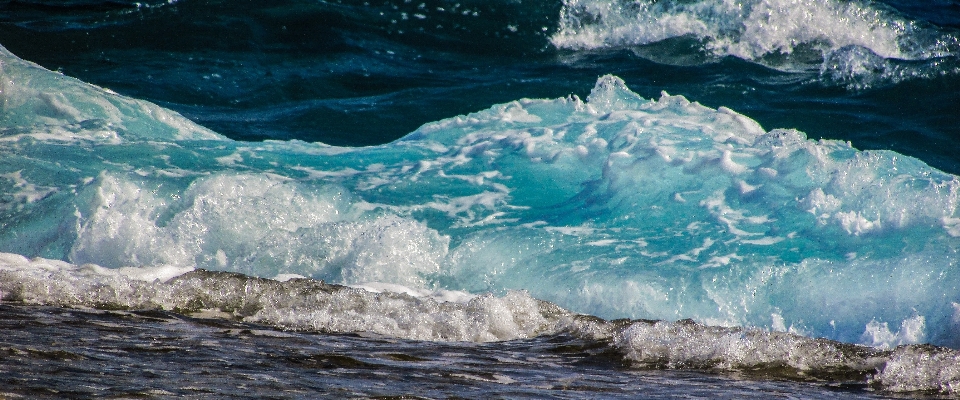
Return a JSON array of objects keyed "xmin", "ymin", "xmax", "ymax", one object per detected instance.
[{"xmin": 0, "ymin": 0, "xmax": 960, "ymax": 173}]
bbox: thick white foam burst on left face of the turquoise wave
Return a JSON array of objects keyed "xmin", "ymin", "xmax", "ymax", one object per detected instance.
[{"xmin": 69, "ymin": 174, "xmax": 448, "ymax": 286}]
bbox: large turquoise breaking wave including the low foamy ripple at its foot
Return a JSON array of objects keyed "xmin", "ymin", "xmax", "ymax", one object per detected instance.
[{"xmin": 0, "ymin": 36, "xmax": 960, "ymax": 393}]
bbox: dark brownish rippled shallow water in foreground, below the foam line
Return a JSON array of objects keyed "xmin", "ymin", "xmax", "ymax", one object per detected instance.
[{"xmin": 0, "ymin": 303, "xmax": 900, "ymax": 399}]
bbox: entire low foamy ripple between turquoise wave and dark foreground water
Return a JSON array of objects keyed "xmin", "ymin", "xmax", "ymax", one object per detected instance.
[{"xmin": 0, "ymin": 253, "xmax": 960, "ymax": 394}]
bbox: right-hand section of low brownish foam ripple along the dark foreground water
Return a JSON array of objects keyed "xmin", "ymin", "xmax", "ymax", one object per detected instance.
[{"xmin": 614, "ymin": 321, "xmax": 960, "ymax": 394}]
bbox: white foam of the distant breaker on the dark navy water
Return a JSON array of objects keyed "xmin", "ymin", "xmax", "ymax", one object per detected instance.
[{"xmin": 552, "ymin": 0, "xmax": 948, "ymax": 59}]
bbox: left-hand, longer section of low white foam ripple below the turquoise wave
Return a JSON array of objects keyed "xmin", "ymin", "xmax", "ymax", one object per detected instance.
[{"xmin": 0, "ymin": 253, "xmax": 571, "ymax": 342}]
